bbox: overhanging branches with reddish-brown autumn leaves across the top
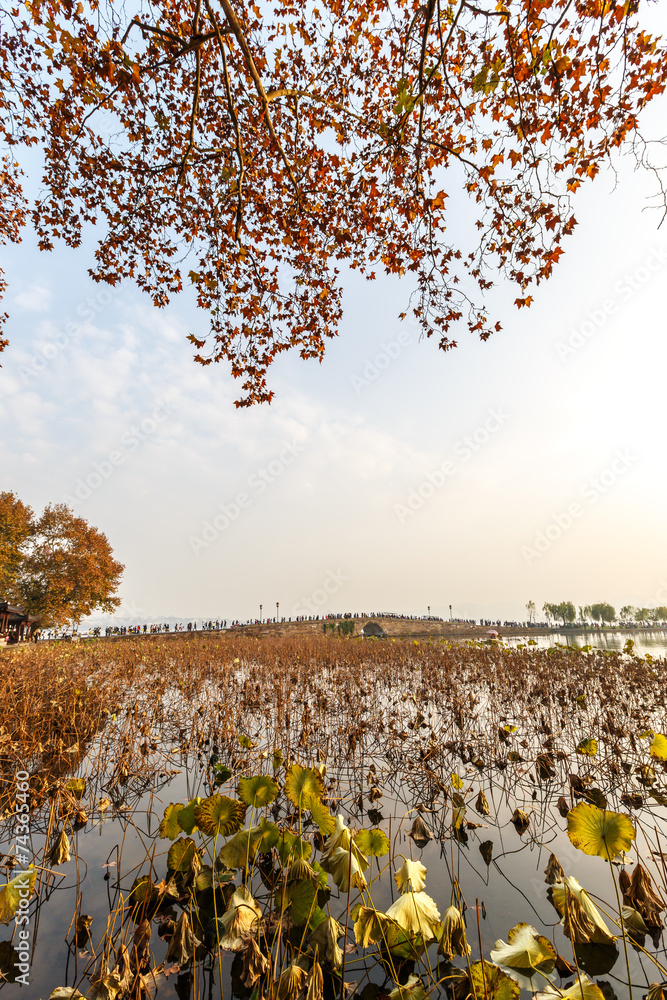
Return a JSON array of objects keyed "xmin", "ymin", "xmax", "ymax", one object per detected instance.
[{"xmin": 0, "ymin": 0, "xmax": 667, "ymax": 405}]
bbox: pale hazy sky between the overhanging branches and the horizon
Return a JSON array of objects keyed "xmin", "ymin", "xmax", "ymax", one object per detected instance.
[{"xmin": 0, "ymin": 58, "xmax": 667, "ymax": 621}]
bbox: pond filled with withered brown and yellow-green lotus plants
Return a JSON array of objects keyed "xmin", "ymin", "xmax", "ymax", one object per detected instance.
[{"xmin": 0, "ymin": 635, "xmax": 667, "ymax": 1000}]
